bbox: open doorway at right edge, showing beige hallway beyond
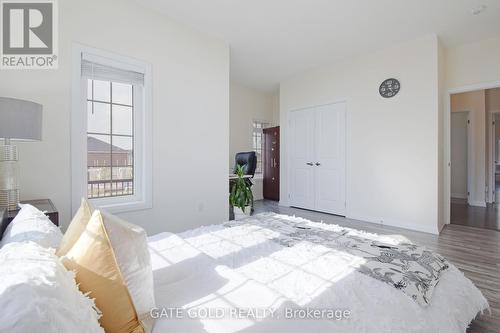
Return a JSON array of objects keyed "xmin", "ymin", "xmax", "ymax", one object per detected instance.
[{"xmin": 450, "ymin": 88, "xmax": 500, "ymax": 230}]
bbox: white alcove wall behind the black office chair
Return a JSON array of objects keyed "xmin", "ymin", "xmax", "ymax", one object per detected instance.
[{"xmin": 229, "ymin": 82, "xmax": 279, "ymax": 200}]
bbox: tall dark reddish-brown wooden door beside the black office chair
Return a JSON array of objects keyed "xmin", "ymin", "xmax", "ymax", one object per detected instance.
[{"xmin": 263, "ymin": 126, "xmax": 280, "ymax": 201}]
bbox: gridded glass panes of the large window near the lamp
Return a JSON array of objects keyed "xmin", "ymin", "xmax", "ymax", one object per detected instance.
[{"xmin": 87, "ymin": 78, "xmax": 136, "ymax": 199}]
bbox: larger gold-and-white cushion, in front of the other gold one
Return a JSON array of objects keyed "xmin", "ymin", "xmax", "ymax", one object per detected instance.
[{"xmin": 63, "ymin": 210, "xmax": 155, "ymax": 333}]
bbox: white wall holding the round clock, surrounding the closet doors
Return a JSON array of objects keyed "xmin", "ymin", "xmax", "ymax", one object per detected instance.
[{"xmin": 280, "ymin": 35, "xmax": 440, "ymax": 233}]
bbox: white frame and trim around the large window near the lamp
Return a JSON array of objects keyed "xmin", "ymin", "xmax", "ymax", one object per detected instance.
[{"xmin": 71, "ymin": 43, "xmax": 153, "ymax": 214}]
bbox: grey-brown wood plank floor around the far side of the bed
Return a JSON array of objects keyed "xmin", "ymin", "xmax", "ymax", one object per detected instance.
[{"xmin": 255, "ymin": 200, "xmax": 500, "ymax": 333}]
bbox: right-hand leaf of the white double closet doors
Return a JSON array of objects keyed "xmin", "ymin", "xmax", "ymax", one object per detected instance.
[{"xmin": 313, "ymin": 103, "xmax": 346, "ymax": 216}]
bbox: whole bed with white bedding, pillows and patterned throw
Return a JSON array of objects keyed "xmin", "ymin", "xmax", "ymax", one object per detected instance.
[{"xmin": 0, "ymin": 205, "xmax": 488, "ymax": 333}]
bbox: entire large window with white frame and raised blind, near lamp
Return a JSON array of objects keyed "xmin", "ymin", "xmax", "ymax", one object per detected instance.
[{"xmin": 71, "ymin": 47, "xmax": 151, "ymax": 212}]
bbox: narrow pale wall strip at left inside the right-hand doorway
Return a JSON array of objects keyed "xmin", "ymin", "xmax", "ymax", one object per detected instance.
[{"xmin": 451, "ymin": 112, "xmax": 468, "ymax": 199}]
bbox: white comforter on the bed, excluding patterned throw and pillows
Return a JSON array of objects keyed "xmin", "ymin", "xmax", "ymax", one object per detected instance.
[{"xmin": 149, "ymin": 214, "xmax": 488, "ymax": 333}]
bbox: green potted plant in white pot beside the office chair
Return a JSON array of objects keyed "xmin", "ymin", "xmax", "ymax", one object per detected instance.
[{"xmin": 229, "ymin": 165, "xmax": 253, "ymax": 220}]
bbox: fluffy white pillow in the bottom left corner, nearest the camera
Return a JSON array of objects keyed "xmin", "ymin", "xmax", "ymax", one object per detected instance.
[{"xmin": 0, "ymin": 242, "xmax": 104, "ymax": 333}]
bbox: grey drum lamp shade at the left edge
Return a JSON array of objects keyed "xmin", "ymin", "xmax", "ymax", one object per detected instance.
[{"xmin": 0, "ymin": 97, "xmax": 42, "ymax": 141}]
